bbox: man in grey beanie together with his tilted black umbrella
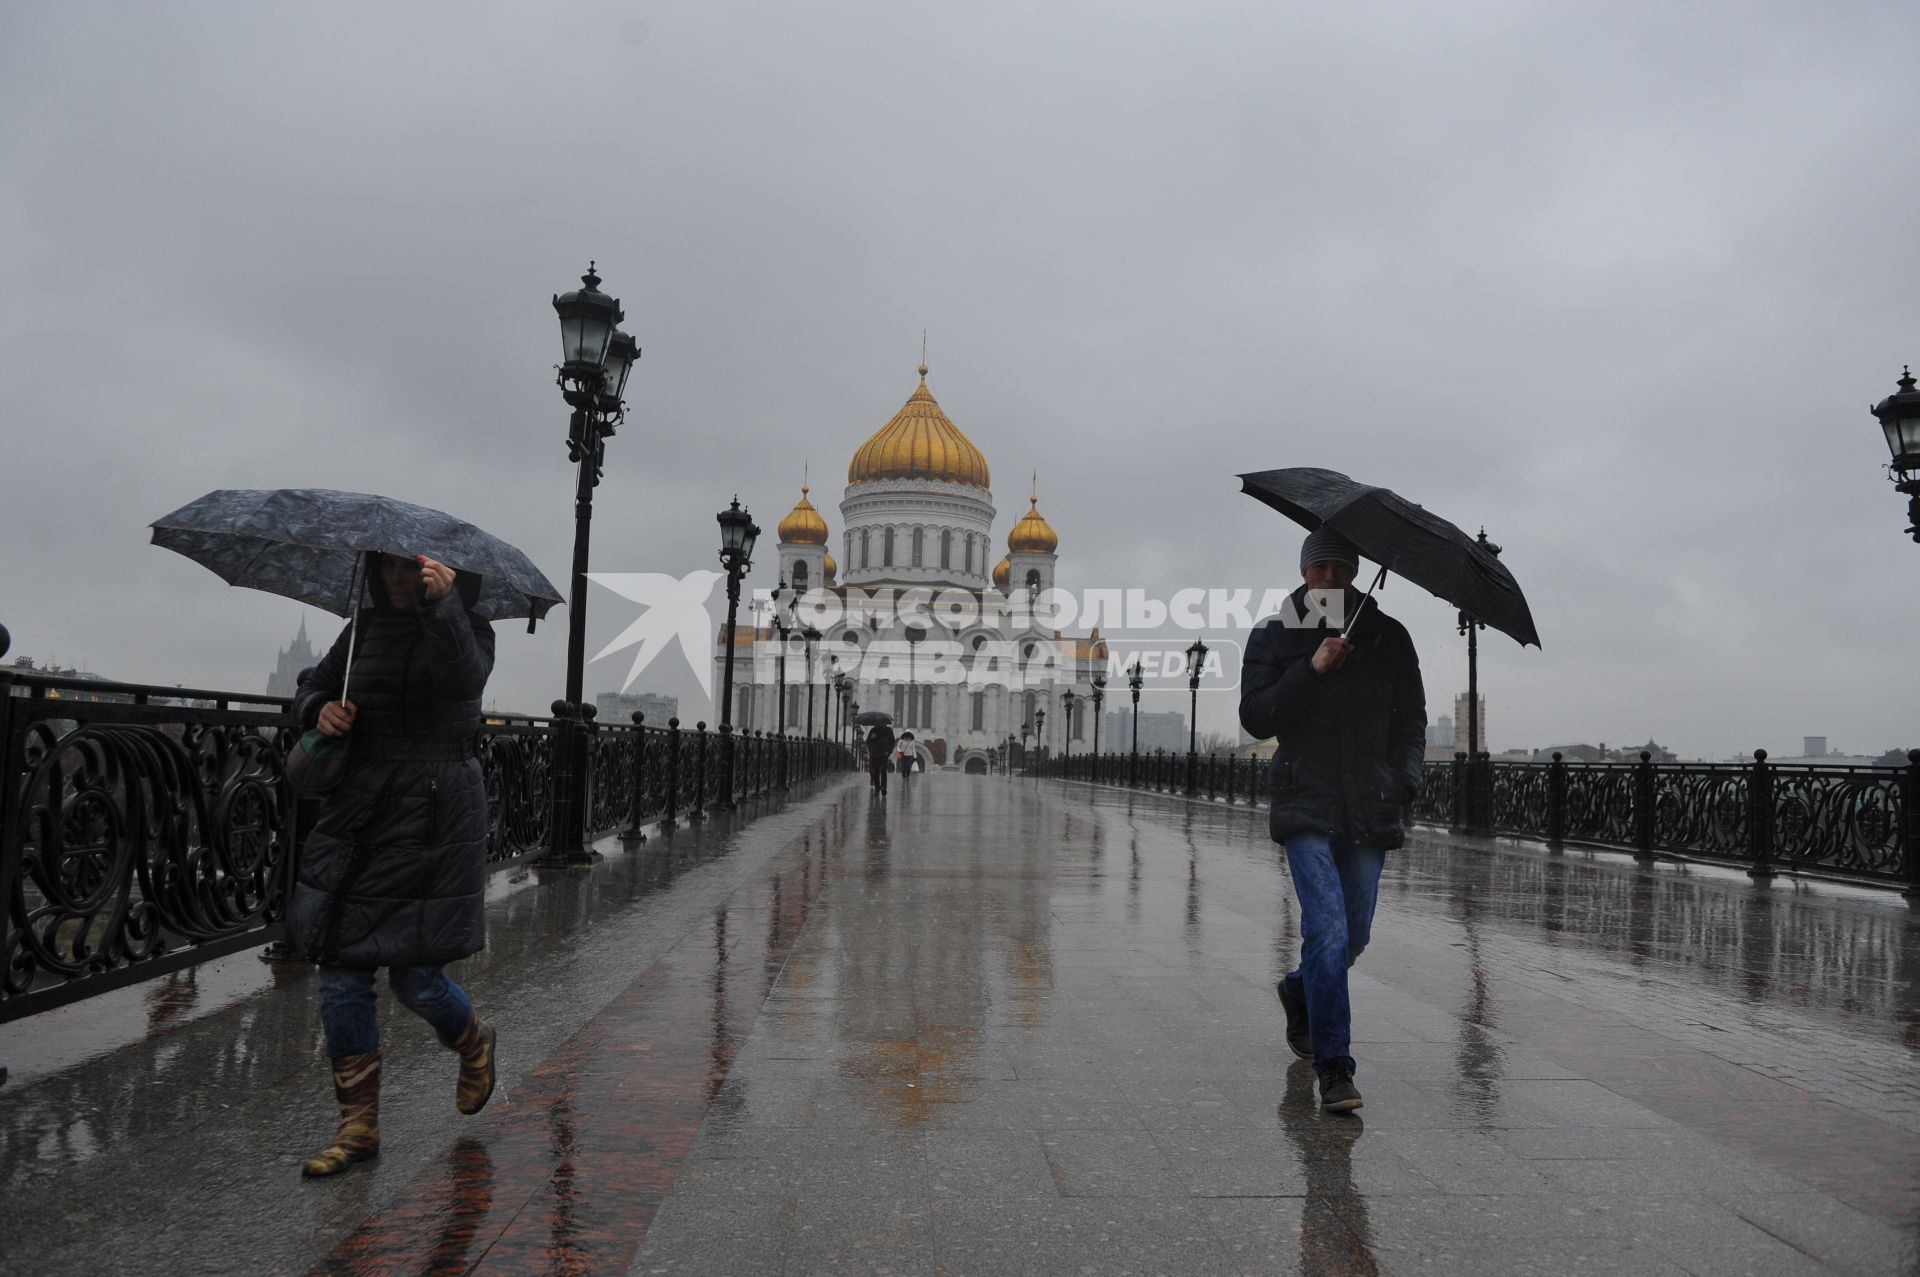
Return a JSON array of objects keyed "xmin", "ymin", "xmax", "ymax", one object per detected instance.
[{"xmin": 1240, "ymin": 469, "xmax": 1540, "ymax": 1112}]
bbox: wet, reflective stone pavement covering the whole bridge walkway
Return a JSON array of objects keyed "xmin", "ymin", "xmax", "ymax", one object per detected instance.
[{"xmin": 0, "ymin": 774, "xmax": 1920, "ymax": 1273}]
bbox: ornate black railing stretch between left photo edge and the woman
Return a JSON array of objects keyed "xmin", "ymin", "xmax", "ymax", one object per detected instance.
[{"xmin": 0, "ymin": 670, "xmax": 303, "ymax": 1020}]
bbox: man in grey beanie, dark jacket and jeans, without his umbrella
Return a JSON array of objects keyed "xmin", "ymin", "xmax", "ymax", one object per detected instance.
[{"xmin": 1240, "ymin": 528, "xmax": 1427, "ymax": 1112}]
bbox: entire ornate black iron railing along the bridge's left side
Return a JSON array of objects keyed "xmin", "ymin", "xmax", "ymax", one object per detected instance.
[{"xmin": 0, "ymin": 670, "xmax": 851, "ymax": 1022}]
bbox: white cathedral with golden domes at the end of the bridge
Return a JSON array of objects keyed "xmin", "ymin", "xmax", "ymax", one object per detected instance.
[{"xmin": 714, "ymin": 365, "xmax": 1110, "ymax": 772}]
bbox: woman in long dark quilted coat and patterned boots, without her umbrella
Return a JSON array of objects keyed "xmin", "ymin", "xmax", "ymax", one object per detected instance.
[{"xmin": 288, "ymin": 553, "xmax": 493, "ymax": 1175}]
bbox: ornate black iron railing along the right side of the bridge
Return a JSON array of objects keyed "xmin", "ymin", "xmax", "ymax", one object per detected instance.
[{"xmin": 1052, "ymin": 749, "xmax": 1920, "ymax": 895}]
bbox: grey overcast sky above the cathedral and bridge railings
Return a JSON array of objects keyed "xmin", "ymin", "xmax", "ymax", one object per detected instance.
[{"xmin": 0, "ymin": 0, "xmax": 1920, "ymax": 757}]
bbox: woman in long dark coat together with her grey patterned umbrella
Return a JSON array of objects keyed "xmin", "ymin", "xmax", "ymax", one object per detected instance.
[{"xmin": 154, "ymin": 490, "xmax": 559, "ymax": 1175}]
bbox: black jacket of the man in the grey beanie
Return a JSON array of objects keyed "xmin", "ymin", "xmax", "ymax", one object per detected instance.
[{"xmin": 1240, "ymin": 586, "xmax": 1427, "ymax": 851}]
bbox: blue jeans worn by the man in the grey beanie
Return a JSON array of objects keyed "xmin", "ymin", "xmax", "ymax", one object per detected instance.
[{"xmin": 1286, "ymin": 833, "xmax": 1386, "ymax": 1073}]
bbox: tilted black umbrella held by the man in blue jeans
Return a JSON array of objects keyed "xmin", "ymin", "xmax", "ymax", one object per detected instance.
[{"xmin": 1240, "ymin": 467, "xmax": 1540, "ymax": 647}]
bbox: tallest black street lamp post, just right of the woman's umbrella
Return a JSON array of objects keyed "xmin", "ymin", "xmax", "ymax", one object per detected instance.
[{"xmin": 538, "ymin": 261, "xmax": 639, "ymax": 868}]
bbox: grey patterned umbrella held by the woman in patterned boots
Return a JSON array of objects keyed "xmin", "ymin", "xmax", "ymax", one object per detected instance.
[{"xmin": 154, "ymin": 488, "xmax": 563, "ymax": 628}]
